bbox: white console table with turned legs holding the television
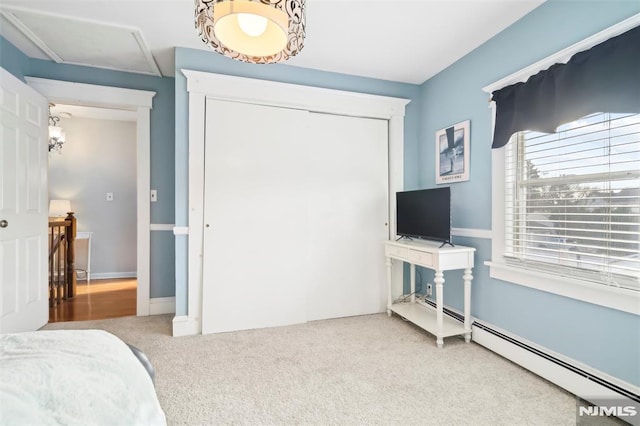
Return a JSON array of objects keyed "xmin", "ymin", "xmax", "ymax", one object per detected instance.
[{"xmin": 384, "ymin": 240, "xmax": 476, "ymax": 348}]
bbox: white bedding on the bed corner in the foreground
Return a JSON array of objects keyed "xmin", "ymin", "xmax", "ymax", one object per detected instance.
[{"xmin": 0, "ymin": 330, "xmax": 166, "ymax": 425}]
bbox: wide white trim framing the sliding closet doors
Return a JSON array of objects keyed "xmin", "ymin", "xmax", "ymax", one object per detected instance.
[{"xmin": 180, "ymin": 70, "xmax": 410, "ymax": 336}]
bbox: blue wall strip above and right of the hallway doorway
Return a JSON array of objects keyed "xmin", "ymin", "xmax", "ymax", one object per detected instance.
[{"xmin": 0, "ymin": 41, "xmax": 175, "ymax": 297}]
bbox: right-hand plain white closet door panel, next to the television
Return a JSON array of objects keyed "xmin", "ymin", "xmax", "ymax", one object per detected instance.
[{"xmin": 305, "ymin": 113, "xmax": 389, "ymax": 321}]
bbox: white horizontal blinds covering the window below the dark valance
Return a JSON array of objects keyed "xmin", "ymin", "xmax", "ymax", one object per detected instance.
[{"xmin": 505, "ymin": 113, "xmax": 640, "ymax": 290}]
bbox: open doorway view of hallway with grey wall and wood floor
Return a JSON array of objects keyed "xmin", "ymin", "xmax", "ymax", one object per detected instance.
[{"xmin": 48, "ymin": 104, "xmax": 137, "ymax": 322}]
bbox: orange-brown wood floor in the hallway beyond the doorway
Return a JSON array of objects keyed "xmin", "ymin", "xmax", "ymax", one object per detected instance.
[{"xmin": 49, "ymin": 278, "xmax": 137, "ymax": 322}]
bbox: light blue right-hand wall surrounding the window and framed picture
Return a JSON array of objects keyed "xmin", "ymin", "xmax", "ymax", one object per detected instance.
[{"xmin": 415, "ymin": 1, "xmax": 640, "ymax": 386}]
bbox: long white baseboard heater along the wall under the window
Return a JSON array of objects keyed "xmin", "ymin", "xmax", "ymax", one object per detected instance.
[{"xmin": 421, "ymin": 299, "xmax": 640, "ymax": 406}]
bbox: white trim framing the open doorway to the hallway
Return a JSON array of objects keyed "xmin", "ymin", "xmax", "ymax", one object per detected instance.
[{"xmin": 25, "ymin": 77, "xmax": 156, "ymax": 316}]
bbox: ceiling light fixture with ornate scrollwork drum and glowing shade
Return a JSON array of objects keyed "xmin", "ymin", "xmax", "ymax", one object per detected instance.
[{"xmin": 195, "ymin": 0, "xmax": 305, "ymax": 64}]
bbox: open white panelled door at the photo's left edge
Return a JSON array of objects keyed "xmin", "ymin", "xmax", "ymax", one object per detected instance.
[{"xmin": 0, "ymin": 68, "xmax": 49, "ymax": 333}]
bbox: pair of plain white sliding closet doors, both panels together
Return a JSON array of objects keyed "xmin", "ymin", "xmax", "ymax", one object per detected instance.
[{"xmin": 202, "ymin": 99, "xmax": 388, "ymax": 333}]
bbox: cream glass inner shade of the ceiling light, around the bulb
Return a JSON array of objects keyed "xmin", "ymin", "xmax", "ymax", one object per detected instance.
[{"xmin": 213, "ymin": 0, "xmax": 288, "ymax": 56}]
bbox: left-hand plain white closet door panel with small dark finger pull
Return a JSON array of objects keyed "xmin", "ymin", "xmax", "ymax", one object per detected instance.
[{"xmin": 202, "ymin": 100, "xmax": 309, "ymax": 333}]
